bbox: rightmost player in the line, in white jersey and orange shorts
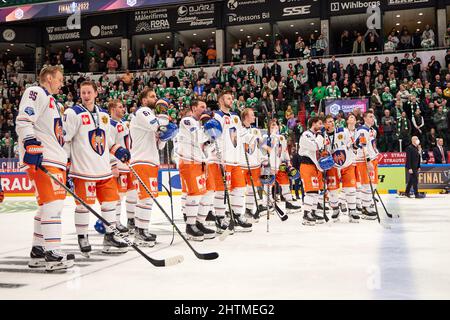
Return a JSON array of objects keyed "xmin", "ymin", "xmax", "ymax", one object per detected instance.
[{"xmin": 355, "ymin": 111, "xmax": 379, "ymax": 220}]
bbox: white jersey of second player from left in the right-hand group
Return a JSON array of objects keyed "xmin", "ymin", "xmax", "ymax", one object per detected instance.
[{"xmin": 325, "ymin": 128, "xmax": 355, "ymax": 169}]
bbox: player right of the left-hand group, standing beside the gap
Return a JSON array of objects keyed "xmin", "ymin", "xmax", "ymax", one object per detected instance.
[{"xmin": 263, "ymin": 119, "xmax": 301, "ymax": 213}]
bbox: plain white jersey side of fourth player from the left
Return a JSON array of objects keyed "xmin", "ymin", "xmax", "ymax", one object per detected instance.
[{"xmin": 130, "ymin": 107, "xmax": 168, "ymax": 166}]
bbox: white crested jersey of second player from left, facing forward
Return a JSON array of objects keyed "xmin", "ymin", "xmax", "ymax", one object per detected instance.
[{"xmin": 64, "ymin": 105, "xmax": 115, "ymax": 180}]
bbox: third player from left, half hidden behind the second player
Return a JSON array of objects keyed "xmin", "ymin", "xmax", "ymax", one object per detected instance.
[{"xmin": 108, "ymin": 100, "xmax": 137, "ymax": 233}]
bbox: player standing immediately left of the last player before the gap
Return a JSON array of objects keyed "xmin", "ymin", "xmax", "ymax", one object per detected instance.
[{"xmin": 241, "ymin": 108, "xmax": 268, "ymax": 220}]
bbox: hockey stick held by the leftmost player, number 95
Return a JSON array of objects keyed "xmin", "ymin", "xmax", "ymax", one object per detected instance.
[{"xmin": 39, "ymin": 166, "xmax": 184, "ymax": 267}]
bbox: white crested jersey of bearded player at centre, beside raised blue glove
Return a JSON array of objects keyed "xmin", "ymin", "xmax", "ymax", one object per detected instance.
[{"xmin": 210, "ymin": 110, "xmax": 255, "ymax": 166}]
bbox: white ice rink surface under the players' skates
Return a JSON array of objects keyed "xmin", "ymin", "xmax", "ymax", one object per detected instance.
[{"xmin": 0, "ymin": 195, "xmax": 450, "ymax": 300}]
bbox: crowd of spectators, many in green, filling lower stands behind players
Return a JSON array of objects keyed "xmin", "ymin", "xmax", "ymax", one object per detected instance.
[{"xmin": 0, "ymin": 39, "xmax": 450, "ymax": 157}]
